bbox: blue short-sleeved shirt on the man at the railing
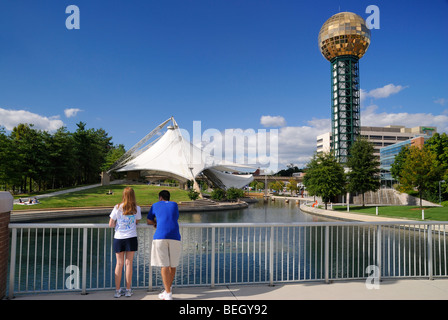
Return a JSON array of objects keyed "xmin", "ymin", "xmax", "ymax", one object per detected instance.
[{"xmin": 147, "ymin": 200, "xmax": 180, "ymax": 241}]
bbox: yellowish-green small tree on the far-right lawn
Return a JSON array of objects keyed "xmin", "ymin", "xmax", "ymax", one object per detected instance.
[{"xmin": 399, "ymin": 146, "xmax": 444, "ymax": 207}]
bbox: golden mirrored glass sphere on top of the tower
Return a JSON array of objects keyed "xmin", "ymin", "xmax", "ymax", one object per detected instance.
[{"xmin": 319, "ymin": 12, "xmax": 370, "ymax": 61}]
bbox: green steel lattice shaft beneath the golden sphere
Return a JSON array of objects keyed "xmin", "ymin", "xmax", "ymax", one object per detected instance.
[{"xmin": 331, "ymin": 55, "xmax": 360, "ymax": 163}]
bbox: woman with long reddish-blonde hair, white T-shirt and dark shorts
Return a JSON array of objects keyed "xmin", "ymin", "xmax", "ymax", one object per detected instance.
[{"xmin": 109, "ymin": 187, "xmax": 142, "ymax": 298}]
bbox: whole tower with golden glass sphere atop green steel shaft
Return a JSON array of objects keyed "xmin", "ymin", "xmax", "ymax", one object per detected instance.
[{"xmin": 319, "ymin": 12, "xmax": 370, "ymax": 163}]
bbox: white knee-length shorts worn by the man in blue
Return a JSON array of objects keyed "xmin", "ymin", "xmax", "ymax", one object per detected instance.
[{"xmin": 151, "ymin": 239, "xmax": 181, "ymax": 268}]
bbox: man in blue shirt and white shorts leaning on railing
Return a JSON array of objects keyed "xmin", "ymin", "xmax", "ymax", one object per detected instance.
[{"xmin": 147, "ymin": 190, "xmax": 181, "ymax": 300}]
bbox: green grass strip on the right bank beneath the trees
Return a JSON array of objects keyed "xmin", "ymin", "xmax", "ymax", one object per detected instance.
[{"xmin": 333, "ymin": 206, "xmax": 448, "ymax": 221}]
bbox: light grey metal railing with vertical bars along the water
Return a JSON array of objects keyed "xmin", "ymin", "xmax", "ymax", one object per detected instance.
[{"xmin": 8, "ymin": 222, "xmax": 448, "ymax": 298}]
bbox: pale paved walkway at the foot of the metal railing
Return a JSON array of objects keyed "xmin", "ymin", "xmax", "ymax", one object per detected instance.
[{"xmin": 10, "ymin": 279, "xmax": 448, "ymax": 301}]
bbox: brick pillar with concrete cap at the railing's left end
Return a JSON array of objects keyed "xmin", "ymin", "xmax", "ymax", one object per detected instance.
[{"xmin": 0, "ymin": 192, "xmax": 13, "ymax": 300}]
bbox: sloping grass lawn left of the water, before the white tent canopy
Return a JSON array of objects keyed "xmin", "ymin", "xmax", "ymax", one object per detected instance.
[{"xmin": 14, "ymin": 185, "xmax": 190, "ymax": 210}]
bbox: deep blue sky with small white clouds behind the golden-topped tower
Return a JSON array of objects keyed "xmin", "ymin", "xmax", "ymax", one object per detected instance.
[{"xmin": 0, "ymin": 0, "xmax": 448, "ymax": 166}]
